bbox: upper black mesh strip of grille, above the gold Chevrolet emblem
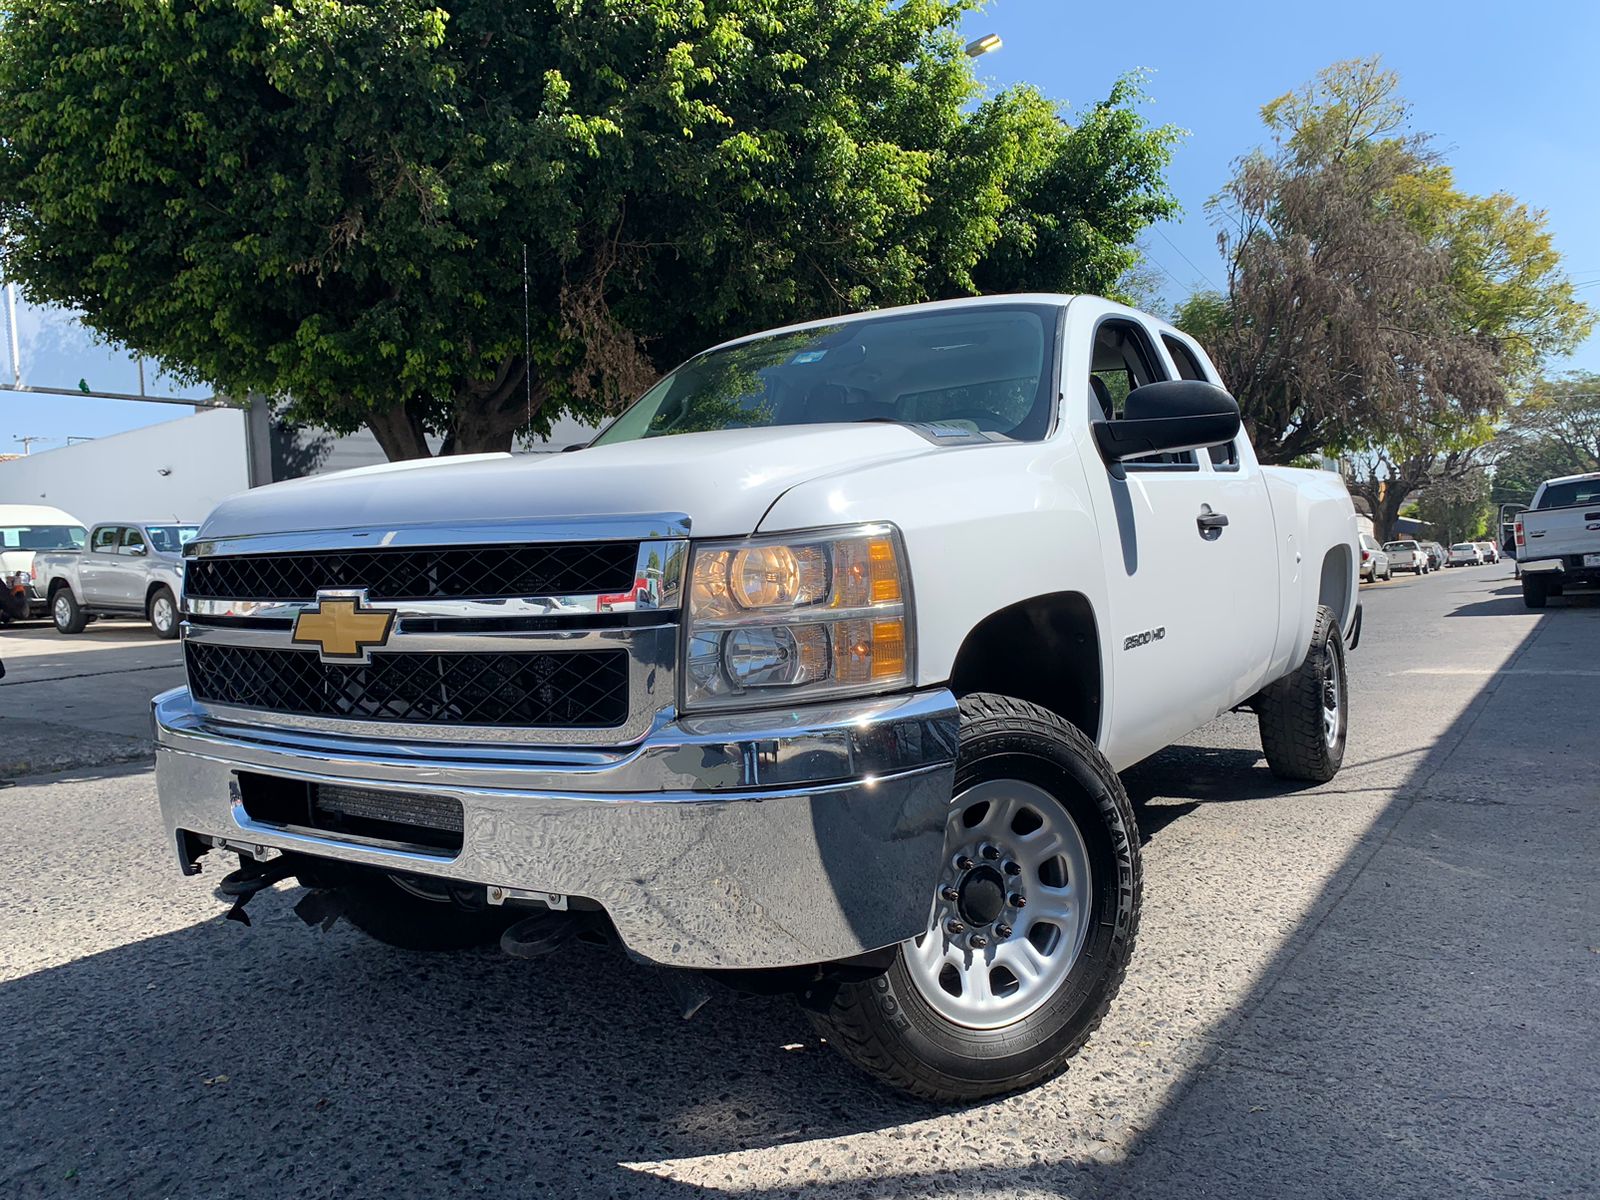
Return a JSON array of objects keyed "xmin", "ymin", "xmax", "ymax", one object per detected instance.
[{"xmin": 184, "ymin": 541, "xmax": 638, "ymax": 602}]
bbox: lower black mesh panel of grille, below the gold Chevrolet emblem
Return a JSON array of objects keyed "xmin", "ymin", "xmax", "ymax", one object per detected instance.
[{"xmin": 184, "ymin": 642, "xmax": 627, "ymax": 728}]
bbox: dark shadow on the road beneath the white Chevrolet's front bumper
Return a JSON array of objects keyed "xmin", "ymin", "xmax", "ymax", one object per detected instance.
[{"xmin": 0, "ymin": 890, "xmax": 938, "ymax": 1197}]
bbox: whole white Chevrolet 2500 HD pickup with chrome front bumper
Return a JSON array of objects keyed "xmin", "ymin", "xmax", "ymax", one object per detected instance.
[{"xmin": 154, "ymin": 296, "xmax": 1360, "ymax": 1099}]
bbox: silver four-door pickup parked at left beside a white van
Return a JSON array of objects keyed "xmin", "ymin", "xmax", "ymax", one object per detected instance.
[{"xmin": 35, "ymin": 522, "xmax": 198, "ymax": 638}]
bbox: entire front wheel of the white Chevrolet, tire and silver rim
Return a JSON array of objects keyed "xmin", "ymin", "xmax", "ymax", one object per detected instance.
[{"xmin": 813, "ymin": 693, "xmax": 1142, "ymax": 1101}]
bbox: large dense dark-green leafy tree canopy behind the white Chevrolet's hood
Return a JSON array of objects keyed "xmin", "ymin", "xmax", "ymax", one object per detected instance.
[{"xmin": 0, "ymin": 0, "xmax": 1178, "ymax": 458}]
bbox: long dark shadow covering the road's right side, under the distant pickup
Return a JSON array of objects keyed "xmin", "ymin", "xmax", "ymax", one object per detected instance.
[{"xmin": 1075, "ymin": 613, "xmax": 1600, "ymax": 1200}]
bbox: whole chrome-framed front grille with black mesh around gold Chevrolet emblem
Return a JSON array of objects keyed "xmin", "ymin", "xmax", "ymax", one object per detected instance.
[{"xmin": 184, "ymin": 514, "xmax": 690, "ymax": 746}]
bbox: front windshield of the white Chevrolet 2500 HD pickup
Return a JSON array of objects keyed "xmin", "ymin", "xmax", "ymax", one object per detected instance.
[{"xmin": 594, "ymin": 304, "xmax": 1054, "ymax": 446}]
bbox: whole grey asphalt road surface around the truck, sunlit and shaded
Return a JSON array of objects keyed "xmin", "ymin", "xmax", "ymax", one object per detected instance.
[{"xmin": 0, "ymin": 566, "xmax": 1600, "ymax": 1200}]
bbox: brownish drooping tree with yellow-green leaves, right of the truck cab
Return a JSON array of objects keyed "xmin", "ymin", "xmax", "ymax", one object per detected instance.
[{"xmin": 1178, "ymin": 58, "xmax": 1594, "ymax": 508}]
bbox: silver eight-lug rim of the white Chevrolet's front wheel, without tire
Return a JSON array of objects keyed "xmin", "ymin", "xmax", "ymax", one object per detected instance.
[{"xmin": 904, "ymin": 779, "xmax": 1093, "ymax": 1029}]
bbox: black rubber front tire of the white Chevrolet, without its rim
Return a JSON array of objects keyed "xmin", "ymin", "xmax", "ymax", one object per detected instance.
[{"xmin": 811, "ymin": 693, "xmax": 1142, "ymax": 1102}]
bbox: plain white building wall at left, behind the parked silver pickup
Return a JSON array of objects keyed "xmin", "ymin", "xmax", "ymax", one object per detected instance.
[{"xmin": 0, "ymin": 408, "xmax": 250, "ymax": 525}]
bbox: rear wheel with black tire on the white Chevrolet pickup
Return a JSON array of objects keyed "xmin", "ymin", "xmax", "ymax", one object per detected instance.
[{"xmin": 1256, "ymin": 605, "xmax": 1350, "ymax": 784}]
